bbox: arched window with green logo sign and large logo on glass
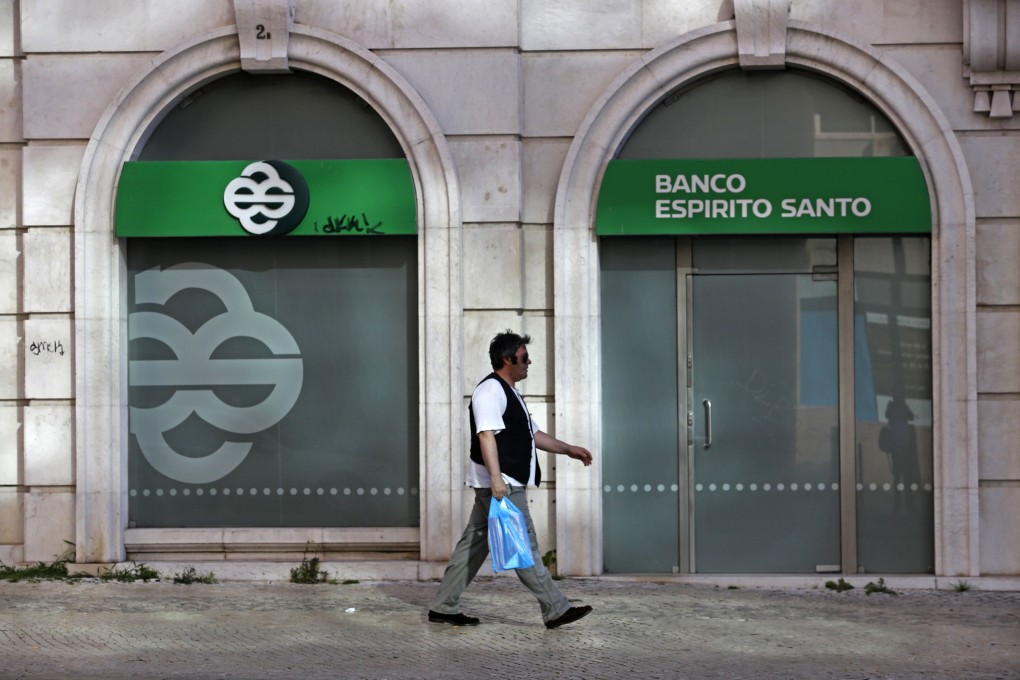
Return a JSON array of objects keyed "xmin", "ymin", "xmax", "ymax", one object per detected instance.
[{"xmin": 116, "ymin": 75, "xmax": 419, "ymax": 534}]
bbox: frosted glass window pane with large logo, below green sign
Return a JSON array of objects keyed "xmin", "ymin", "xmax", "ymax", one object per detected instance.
[{"xmin": 128, "ymin": 237, "xmax": 418, "ymax": 527}]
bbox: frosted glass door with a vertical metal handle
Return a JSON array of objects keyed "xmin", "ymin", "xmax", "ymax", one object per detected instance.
[{"xmin": 690, "ymin": 274, "xmax": 839, "ymax": 573}]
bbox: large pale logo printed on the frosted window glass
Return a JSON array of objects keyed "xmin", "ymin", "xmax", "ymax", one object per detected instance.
[{"xmin": 129, "ymin": 263, "xmax": 304, "ymax": 484}]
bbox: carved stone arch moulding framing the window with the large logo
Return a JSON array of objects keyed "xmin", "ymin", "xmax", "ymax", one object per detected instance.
[{"xmin": 74, "ymin": 24, "xmax": 462, "ymax": 563}]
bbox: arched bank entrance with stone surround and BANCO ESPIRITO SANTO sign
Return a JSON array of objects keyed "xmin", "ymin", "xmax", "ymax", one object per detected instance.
[{"xmin": 556, "ymin": 27, "xmax": 973, "ymax": 576}]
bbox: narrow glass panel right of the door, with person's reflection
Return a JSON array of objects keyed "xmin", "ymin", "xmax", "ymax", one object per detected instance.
[{"xmin": 854, "ymin": 238, "xmax": 934, "ymax": 573}]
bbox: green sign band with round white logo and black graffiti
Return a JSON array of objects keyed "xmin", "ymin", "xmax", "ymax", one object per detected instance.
[{"xmin": 116, "ymin": 158, "xmax": 417, "ymax": 237}]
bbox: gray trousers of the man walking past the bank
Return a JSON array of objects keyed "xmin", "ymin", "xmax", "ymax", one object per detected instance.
[{"xmin": 429, "ymin": 486, "xmax": 570, "ymax": 622}]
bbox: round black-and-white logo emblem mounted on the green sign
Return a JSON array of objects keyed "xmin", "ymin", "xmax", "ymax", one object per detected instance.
[{"xmin": 223, "ymin": 160, "xmax": 308, "ymax": 236}]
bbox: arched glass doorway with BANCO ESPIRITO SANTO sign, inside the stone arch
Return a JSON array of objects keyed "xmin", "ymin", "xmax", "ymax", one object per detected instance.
[{"xmin": 596, "ymin": 69, "xmax": 934, "ymax": 573}]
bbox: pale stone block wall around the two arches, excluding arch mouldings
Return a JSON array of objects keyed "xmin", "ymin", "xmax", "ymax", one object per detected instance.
[{"xmin": 0, "ymin": 0, "xmax": 1020, "ymax": 576}]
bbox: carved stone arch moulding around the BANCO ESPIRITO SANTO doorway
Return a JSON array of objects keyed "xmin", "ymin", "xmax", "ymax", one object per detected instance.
[{"xmin": 553, "ymin": 21, "xmax": 979, "ymax": 576}]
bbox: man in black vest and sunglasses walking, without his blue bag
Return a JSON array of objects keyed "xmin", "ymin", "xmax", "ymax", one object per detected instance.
[{"xmin": 428, "ymin": 330, "xmax": 592, "ymax": 628}]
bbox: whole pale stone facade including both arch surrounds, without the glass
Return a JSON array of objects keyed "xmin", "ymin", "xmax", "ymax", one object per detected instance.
[{"xmin": 0, "ymin": 0, "xmax": 1020, "ymax": 578}]
